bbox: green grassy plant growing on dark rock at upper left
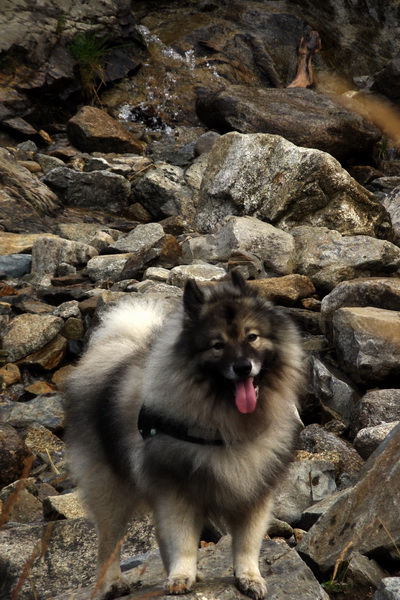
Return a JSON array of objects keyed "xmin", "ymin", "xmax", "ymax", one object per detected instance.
[{"xmin": 68, "ymin": 32, "xmax": 110, "ymax": 102}]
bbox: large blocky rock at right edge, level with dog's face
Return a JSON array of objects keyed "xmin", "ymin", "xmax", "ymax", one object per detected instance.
[{"xmin": 333, "ymin": 307, "xmax": 400, "ymax": 386}]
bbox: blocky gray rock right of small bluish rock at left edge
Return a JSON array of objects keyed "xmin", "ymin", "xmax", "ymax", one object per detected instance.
[{"xmin": 32, "ymin": 236, "xmax": 98, "ymax": 275}]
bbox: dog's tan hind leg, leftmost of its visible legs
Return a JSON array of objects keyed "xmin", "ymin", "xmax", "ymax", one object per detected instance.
[{"xmin": 84, "ymin": 474, "xmax": 135, "ymax": 600}]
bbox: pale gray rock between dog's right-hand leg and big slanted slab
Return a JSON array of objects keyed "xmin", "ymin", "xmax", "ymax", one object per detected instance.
[{"xmin": 273, "ymin": 460, "xmax": 336, "ymax": 525}]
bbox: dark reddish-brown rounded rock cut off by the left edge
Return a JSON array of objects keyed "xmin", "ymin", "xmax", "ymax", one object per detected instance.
[{"xmin": 0, "ymin": 422, "xmax": 30, "ymax": 488}]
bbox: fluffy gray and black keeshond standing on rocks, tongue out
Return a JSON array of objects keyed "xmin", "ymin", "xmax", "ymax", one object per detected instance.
[{"xmin": 66, "ymin": 271, "xmax": 302, "ymax": 600}]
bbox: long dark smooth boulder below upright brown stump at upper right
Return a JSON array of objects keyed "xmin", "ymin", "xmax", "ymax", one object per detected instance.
[{"xmin": 196, "ymin": 85, "xmax": 381, "ymax": 160}]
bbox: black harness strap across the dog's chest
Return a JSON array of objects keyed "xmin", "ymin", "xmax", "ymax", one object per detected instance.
[{"xmin": 138, "ymin": 406, "xmax": 224, "ymax": 446}]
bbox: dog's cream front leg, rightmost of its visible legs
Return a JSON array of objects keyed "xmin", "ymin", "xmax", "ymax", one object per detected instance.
[{"xmin": 231, "ymin": 499, "xmax": 271, "ymax": 600}]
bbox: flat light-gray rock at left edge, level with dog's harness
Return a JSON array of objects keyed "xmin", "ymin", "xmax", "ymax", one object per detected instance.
[{"xmin": 0, "ymin": 394, "xmax": 65, "ymax": 431}]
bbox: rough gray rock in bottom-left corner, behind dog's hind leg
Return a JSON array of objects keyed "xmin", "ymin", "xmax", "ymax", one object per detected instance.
[{"xmin": 0, "ymin": 519, "xmax": 155, "ymax": 600}]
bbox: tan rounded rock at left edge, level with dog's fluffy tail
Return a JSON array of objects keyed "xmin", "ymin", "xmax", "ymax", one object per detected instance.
[{"xmin": 3, "ymin": 313, "xmax": 64, "ymax": 362}]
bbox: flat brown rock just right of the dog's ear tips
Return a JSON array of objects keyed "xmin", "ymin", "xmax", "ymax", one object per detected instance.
[{"xmin": 247, "ymin": 274, "xmax": 315, "ymax": 306}]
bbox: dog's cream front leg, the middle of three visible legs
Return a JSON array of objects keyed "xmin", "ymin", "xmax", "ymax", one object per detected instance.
[{"xmin": 154, "ymin": 493, "xmax": 203, "ymax": 594}]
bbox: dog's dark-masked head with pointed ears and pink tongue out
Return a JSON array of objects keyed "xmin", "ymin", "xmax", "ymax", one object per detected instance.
[{"xmin": 181, "ymin": 271, "xmax": 298, "ymax": 413}]
